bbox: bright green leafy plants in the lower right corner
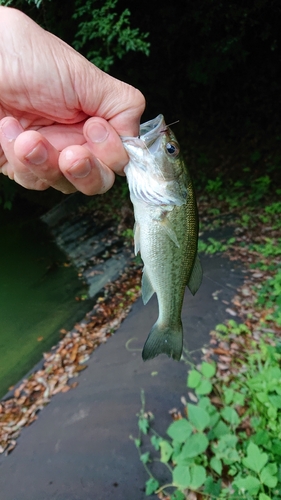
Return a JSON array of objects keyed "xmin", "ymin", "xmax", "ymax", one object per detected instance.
[{"xmin": 135, "ymin": 332, "xmax": 281, "ymax": 500}]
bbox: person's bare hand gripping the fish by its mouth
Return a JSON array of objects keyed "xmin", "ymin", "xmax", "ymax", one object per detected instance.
[{"xmin": 0, "ymin": 6, "xmax": 145, "ymax": 195}]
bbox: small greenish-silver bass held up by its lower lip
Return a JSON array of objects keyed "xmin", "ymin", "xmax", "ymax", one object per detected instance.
[{"xmin": 122, "ymin": 114, "xmax": 202, "ymax": 361}]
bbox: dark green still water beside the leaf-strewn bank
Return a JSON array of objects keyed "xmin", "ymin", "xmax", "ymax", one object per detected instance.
[{"xmin": 0, "ymin": 213, "xmax": 89, "ymax": 396}]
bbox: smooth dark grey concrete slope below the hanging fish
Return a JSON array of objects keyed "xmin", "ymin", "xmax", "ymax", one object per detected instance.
[{"xmin": 0, "ymin": 256, "xmax": 243, "ymax": 500}]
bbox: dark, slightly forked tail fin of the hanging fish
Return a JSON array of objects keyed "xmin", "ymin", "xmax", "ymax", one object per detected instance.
[{"xmin": 142, "ymin": 322, "xmax": 183, "ymax": 361}]
